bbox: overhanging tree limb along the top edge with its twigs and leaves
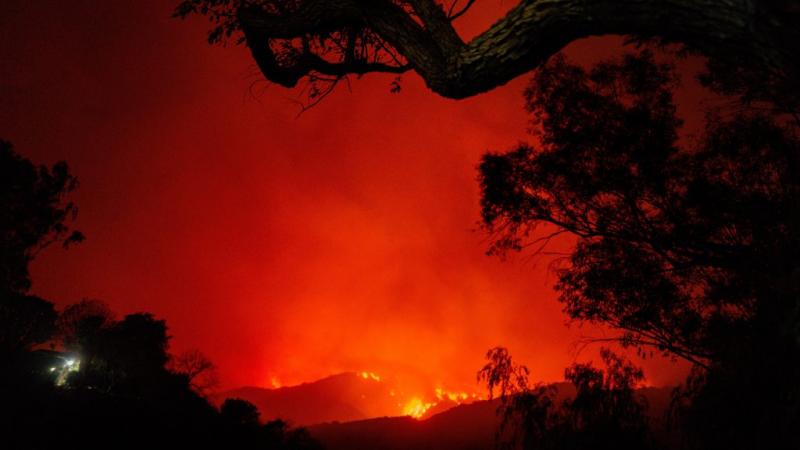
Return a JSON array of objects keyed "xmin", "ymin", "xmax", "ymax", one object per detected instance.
[{"xmin": 176, "ymin": 0, "xmax": 800, "ymax": 100}]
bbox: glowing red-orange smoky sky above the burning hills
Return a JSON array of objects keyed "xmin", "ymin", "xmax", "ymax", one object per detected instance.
[{"xmin": 0, "ymin": 0, "xmax": 684, "ymax": 390}]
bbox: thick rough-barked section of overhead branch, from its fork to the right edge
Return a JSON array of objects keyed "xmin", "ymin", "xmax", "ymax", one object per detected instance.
[{"xmin": 444, "ymin": 0, "xmax": 797, "ymax": 97}]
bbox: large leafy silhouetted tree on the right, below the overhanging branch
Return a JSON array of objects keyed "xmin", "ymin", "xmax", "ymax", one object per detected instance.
[{"xmin": 480, "ymin": 51, "xmax": 800, "ymax": 448}]
